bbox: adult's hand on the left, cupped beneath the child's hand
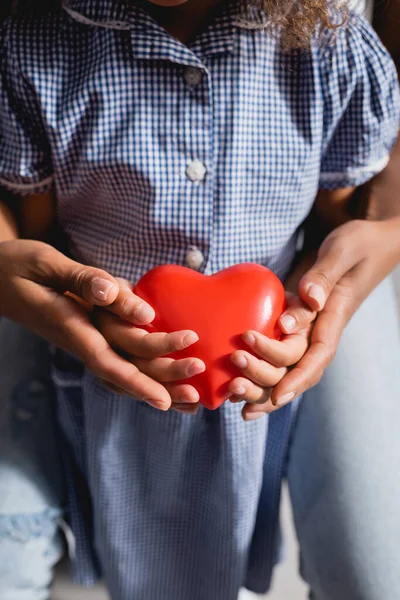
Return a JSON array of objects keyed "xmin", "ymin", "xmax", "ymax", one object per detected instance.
[{"xmin": 0, "ymin": 240, "xmax": 201, "ymax": 410}]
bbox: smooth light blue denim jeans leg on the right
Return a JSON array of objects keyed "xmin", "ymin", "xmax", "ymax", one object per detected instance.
[{"xmin": 288, "ymin": 279, "xmax": 400, "ymax": 600}]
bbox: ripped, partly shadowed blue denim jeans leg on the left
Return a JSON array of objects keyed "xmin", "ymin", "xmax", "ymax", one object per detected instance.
[{"xmin": 0, "ymin": 319, "xmax": 63, "ymax": 600}]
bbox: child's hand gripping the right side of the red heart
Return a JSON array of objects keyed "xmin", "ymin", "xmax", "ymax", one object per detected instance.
[{"xmin": 229, "ymin": 293, "xmax": 316, "ymax": 421}]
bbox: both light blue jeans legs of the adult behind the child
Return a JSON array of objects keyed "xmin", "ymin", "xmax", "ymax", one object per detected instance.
[{"xmin": 0, "ymin": 280, "xmax": 400, "ymax": 600}]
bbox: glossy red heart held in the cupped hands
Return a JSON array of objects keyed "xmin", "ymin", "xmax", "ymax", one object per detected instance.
[{"xmin": 133, "ymin": 263, "xmax": 286, "ymax": 410}]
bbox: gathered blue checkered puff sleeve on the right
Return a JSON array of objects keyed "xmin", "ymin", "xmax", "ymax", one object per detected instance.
[{"xmin": 318, "ymin": 15, "xmax": 400, "ymax": 190}]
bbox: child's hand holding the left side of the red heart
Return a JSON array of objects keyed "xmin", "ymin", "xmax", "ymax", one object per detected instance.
[{"xmin": 95, "ymin": 279, "xmax": 205, "ymax": 414}]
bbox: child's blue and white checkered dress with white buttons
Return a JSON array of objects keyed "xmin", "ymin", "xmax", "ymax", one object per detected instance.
[{"xmin": 0, "ymin": 0, "xmax": 399, "ymax": 600}]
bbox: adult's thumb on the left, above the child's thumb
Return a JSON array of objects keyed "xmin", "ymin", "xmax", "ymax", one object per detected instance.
[{"xmin": 29, "ymin": 246, "xmax": 119, "ymax": 306}]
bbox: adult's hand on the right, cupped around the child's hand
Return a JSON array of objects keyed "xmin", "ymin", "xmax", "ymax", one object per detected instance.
[{"xmin": 268, "ymin": 217, "xmax": 400, "ymax": 410}]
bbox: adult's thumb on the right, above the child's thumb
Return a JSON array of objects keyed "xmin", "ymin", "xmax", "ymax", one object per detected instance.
[{"xmin": 299, "ymin": 236, "xmax": 360, "ymax": 311}]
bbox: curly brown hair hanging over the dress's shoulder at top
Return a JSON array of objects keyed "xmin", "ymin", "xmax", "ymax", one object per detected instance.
[{"xmin": 6, "ymin": 0, "xmax": 348, "ymax": 48}]
